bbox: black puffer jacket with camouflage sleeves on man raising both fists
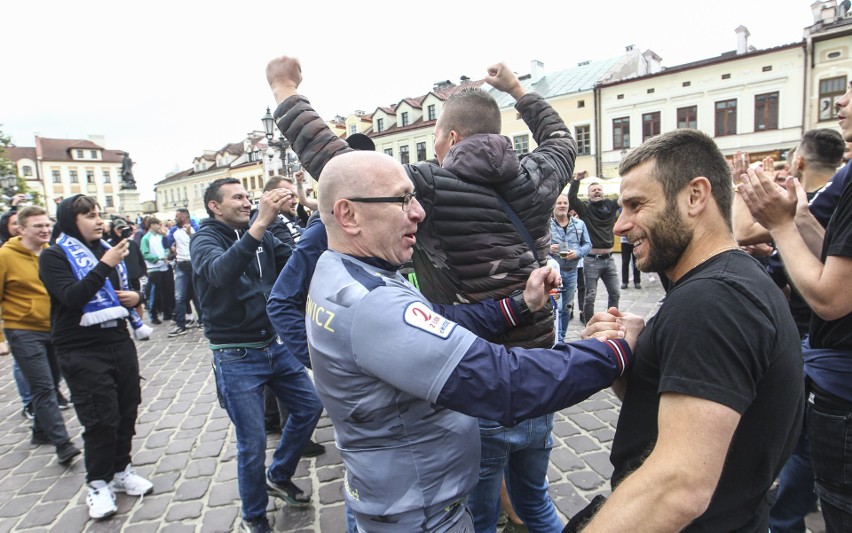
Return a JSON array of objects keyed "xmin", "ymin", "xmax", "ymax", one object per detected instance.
[{"xmin": 275, "ymin": 93, "xmax": 576, "ymax": 347}]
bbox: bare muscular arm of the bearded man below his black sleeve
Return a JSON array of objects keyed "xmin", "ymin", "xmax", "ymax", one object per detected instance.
[{"xmin": 583, "ymin": 393, "xmax": 740, "ymax": 533}]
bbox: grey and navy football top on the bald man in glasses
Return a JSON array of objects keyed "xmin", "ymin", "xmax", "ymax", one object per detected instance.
[{"xmin": 306, "ymin": 250, "xmax": 632, "ymax": 516}]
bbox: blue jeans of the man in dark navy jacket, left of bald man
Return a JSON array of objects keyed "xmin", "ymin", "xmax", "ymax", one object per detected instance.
[{"xmin": 213, "ymin": 341, "xmax": 322, "ymax": 520}]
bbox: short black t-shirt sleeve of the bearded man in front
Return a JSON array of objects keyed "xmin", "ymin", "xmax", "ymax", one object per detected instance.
[{"xmin": 654, "ymin": 280, "xmax": 775, "ymax": 414}]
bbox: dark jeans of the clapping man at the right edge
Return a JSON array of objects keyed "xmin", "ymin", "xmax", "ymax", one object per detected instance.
[{"xmin": 807, "ymin": 394, "xmax": 852, "ymax": 532}]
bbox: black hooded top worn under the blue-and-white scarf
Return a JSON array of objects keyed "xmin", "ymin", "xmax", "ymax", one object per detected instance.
[{"xmin": 38, "ymin": 195, "xmax": 136, "ymax": 353}]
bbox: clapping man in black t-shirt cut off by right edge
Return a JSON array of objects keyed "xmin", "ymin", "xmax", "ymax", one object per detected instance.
[{"xmin": 740, "ymin": 83, "xmax": 852, "ymax": 531}]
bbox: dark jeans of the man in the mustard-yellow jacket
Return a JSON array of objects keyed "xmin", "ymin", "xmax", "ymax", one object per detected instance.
[{"xmin": 5, "ymin": 329, "xmax": 69, "ymax": 446}]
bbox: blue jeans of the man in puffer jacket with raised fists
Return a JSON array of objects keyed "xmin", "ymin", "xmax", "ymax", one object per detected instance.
[{"xmin": 467, "ymin": 414, "xmax": 563, "ymax": 533}]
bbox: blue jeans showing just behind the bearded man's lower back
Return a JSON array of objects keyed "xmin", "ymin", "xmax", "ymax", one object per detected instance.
[{"xmin": 769, "ymin": 406, "xmax": 817, "ymax": 533}]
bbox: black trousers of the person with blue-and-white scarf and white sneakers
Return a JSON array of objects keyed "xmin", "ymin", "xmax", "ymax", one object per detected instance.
[{"xmin": 59, "ymin": 336, "xmax": 142, "ymax": 483}]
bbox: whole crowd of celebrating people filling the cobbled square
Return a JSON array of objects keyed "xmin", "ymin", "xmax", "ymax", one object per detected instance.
[{"xmin": 0, "ymin": 56, "xmax": 852, "ymax": 532}]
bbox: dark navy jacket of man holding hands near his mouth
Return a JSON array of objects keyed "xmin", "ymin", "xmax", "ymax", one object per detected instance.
[{"xmin": 189, "ymin": 218, "xmax": 290, "ymax": 346}]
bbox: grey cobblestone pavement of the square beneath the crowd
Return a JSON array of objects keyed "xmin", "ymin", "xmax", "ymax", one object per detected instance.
[{"xmin": 0, "ymin": 260, "xmax": 821, "ymax": 533}]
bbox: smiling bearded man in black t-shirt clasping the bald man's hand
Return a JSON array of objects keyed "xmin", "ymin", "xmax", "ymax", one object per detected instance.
[{"xmin": 569, "ymin": 130, "xmax": 804, "ymax": 532}]
